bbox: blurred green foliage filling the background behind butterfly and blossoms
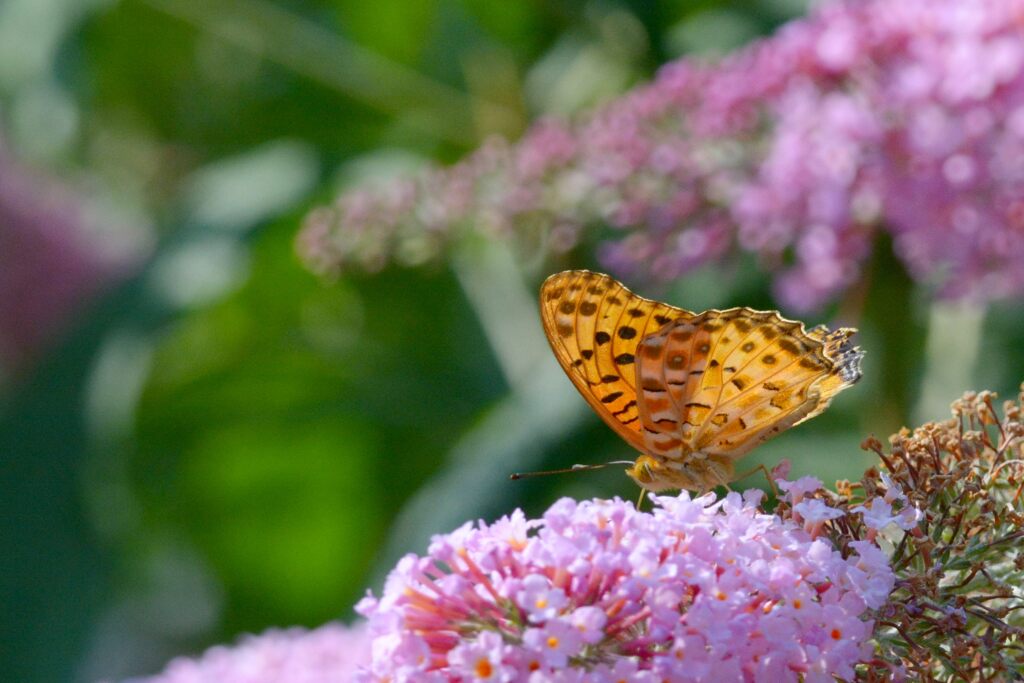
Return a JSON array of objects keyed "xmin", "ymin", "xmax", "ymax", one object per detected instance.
[{"xmin": 0, "ymin": 0, "xmax": 1024, "ymax": 683}]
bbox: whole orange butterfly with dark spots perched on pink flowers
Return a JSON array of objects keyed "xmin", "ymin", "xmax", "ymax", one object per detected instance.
[{"xmin": 541, "ymin": 270, "xmax": 864, "ymax": 493}]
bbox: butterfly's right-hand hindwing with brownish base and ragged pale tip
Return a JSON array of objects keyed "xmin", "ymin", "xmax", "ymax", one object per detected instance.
[{"xmin": 638, "ymin": 308, "xmax": 862, "ymax": 460}]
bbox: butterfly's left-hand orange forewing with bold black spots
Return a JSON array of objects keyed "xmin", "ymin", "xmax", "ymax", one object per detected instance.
[{"xmin": 541, "ymin": 270, "xmax": 693, "ymax": 451}]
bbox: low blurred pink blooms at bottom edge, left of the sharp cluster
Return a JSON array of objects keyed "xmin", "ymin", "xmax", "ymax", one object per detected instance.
[{"xmin": 136, "ymin": 624, "xmax": 371, "ymax": 683}]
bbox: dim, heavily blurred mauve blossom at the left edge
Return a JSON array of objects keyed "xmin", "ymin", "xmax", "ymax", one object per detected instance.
[{"xmin": 0, "ymin": 148, "xmax": 131, "ymax": 371}]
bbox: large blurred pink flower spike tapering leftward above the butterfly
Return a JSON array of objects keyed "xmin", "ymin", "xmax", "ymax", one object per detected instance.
[{"xmin": 299, "ymin": 0, "xmax": 1024, "ymax": 309}]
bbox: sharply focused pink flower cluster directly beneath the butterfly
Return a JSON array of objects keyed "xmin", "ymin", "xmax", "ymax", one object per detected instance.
[{"xmin": 356, "ymin": 491, "xmax": 894, "ymax": 683}]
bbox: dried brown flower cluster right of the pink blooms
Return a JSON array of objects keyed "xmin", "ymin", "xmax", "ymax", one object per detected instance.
[{"xmin": 838, "ymin": 386, "xmax": 1024, "ymax": 681}]
